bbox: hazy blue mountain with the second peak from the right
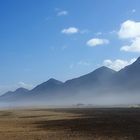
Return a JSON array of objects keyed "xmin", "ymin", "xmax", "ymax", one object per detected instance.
[{"xmin": 64, "ymin": 66, "xmax": 116, "ymax": 92}]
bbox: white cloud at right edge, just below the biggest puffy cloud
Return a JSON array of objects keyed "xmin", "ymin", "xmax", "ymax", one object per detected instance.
[{"xmin": 120, "ymin": 37, "xmax": 140, "ymax": 52}]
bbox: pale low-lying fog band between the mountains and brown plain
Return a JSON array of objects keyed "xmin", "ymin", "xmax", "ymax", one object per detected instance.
[{"xmin": 0, "ymin": 93, "xmax": 140, "ymax": 108}]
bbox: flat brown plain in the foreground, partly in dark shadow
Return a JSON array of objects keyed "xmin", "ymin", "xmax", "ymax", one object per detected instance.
[{"xmin": 0, "ymin": 108, "xmax": 140, "ymax": 140}]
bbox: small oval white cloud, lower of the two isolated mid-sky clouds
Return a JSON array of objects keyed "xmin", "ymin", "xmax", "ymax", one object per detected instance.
[{"xmin": 87, "ymin": 38, "xmax": 109, "ymax": 47}]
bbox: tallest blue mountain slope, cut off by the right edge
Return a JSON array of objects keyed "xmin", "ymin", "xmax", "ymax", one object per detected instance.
[{"xmin": 112, "ymin": 57, "xmax": 140, "ymax": 91}]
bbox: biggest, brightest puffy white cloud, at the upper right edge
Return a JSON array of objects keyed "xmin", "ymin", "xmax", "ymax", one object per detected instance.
[{"xmin": 118, "ymin": 20, "xmax": 140, "ymax": 39}]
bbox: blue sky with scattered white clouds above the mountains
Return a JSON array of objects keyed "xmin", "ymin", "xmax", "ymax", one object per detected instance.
[{"xmin": 0, "ymin": 0, "xmax": 140, "ymax": 94}]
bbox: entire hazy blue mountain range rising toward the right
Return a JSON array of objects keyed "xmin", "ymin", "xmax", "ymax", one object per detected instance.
[{"xmin": 0, "ymin": 57, "xmax": 140, "ymax": 104}]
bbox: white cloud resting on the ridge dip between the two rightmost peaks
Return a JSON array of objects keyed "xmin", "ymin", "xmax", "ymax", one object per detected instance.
[{"xmin": 103, "ymin": 58, "xmax": 136, "ymax": 71}]
